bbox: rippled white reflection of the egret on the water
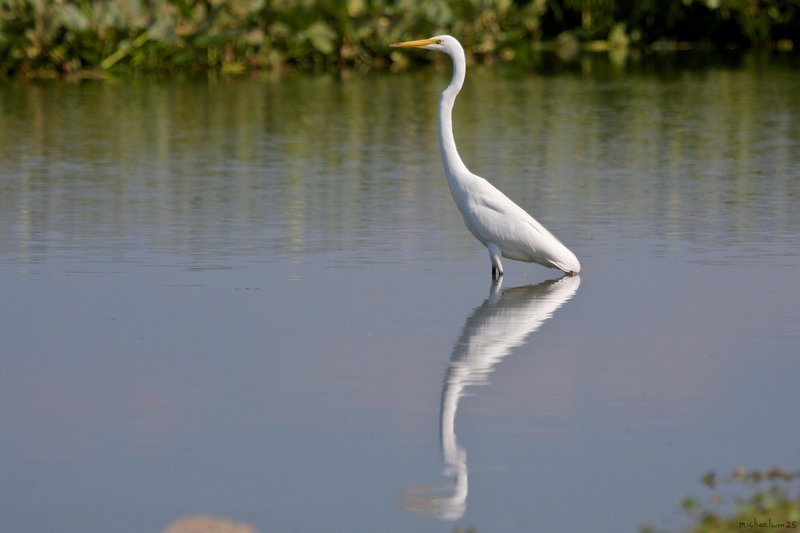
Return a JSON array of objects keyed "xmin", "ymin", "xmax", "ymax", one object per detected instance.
[{"xmin": 406, "ymin": 275, "xmax": 581, "ymax": 520}]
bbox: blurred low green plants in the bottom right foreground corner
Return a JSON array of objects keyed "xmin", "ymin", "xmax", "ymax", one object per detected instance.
[{"xmin": 641, "ymin": 467, "xmax": 800, "ymax": 533}]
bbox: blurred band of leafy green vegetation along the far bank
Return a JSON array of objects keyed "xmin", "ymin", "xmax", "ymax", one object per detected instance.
[{"xmin": 0, "ymin": 0, "xmax": 800, "ymax": 76}]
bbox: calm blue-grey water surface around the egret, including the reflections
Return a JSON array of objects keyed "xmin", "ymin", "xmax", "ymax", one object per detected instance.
[{"xmin": 0, "ymin": 55, "xmax": 800, "ymax": 532}]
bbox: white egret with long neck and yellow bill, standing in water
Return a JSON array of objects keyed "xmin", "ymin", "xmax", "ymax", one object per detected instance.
[{"xmin": 391, "ymin": 35, "xmax": 581, "ymax": 279}]
